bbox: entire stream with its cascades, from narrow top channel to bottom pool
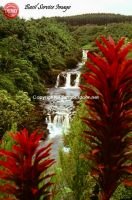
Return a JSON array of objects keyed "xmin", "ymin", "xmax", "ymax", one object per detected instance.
[{"xmin": 40, "ymin": 52, "xmax": 86, "ymax": 158}]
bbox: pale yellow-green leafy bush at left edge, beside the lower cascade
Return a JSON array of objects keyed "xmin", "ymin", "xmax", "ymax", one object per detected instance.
[{"xmin": 0, "ymin": 90, "xmax": 33, "ymax": 133}]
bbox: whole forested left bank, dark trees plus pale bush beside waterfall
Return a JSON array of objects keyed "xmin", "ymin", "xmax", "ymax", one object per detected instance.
[{"xmin": 0, "ymin": 8, "xmax": 80, "ymax": 134}]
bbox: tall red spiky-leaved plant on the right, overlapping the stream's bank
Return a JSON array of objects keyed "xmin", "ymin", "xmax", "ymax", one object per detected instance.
[{"xmin": 81, "ymin": 36, "xmax": 132, "ymax": 200}]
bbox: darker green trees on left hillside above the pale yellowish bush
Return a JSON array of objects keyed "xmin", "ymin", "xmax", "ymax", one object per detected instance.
[{"xmin": 0, "ymin": 9, "xmax": 78, "ymax": 95}]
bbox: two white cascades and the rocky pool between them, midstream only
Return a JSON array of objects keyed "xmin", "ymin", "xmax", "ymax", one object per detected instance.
[{"xmin": 46, "ymin": 69, "xmax": 80, "ymax": 139}]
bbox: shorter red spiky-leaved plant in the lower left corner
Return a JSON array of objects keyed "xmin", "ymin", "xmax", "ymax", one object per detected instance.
[{"xmin": 0, "ymin": 129, "xmax": 54, "ymax": 200}]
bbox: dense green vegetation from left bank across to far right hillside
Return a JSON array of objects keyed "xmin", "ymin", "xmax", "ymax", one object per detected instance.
[{"xmin": 0, "ymin": 12, "xmax": 132, "ymax": 134}]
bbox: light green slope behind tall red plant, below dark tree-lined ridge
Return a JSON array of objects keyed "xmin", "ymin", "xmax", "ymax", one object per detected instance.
[{"xmin": 72, "ymin": 23, "xmax": 132, "ymax": 48}]
